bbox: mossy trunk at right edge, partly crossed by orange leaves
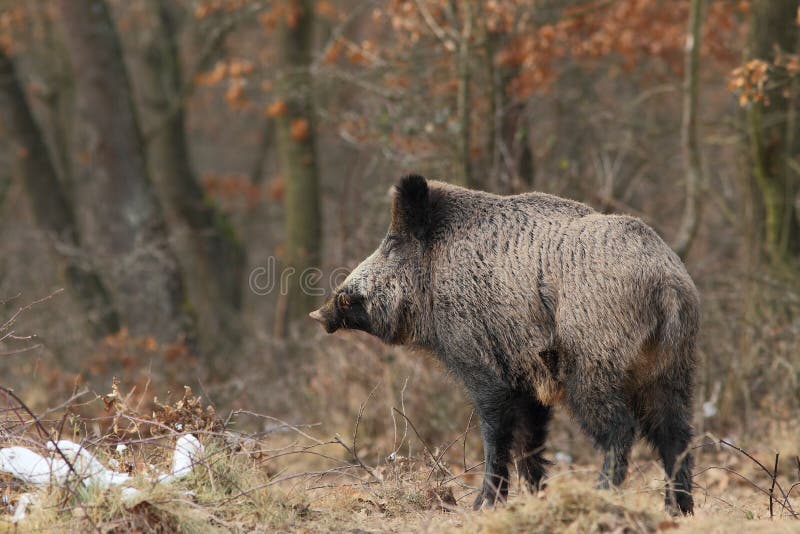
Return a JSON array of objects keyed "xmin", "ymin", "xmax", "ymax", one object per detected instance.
[{"xmin": 747, "ymin": 0, "xmax": 800, "ymax": 264}]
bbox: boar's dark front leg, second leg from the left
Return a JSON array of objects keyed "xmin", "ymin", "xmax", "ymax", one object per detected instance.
[{"xmin": 514, "ymin": 394, "xmax": 552, "ymax": 491}]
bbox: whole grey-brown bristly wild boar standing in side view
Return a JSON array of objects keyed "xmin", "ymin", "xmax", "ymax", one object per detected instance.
[{"xmin": 310, "ymin": 175, "xmax": 699, "ymax": 514}]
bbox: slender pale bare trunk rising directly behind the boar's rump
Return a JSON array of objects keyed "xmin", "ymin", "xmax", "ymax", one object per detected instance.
[{"xmin": 672, "ymin": 0, "xmax": 703, "ymax": 259}]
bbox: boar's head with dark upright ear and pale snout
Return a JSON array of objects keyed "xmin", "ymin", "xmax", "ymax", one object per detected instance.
[{"xmin": 309, "ymin": 175, "xmax": 432, "ymax": 344}]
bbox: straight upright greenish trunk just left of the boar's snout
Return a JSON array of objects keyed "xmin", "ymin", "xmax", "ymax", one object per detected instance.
[{"xmin": 276, "ymin": 0, "xmax": 322, "ymax": 333}]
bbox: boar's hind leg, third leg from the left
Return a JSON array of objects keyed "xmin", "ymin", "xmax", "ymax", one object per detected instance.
[{"xmin": 566, "ymin": 368, "xmax": 636, "ymax": 489}]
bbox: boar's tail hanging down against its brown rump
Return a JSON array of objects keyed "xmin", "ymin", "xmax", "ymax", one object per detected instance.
[{"xmin": 655, "ymin": 278, "xmax": 700, "ymax": 374}]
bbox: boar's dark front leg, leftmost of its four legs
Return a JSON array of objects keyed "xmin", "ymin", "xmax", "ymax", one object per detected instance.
[{"xmin": 468, "ymin": 383, "xmax": 514, "ymax": 510}]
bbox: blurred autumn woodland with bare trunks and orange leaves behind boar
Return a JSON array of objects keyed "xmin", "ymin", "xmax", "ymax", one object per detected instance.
[{"xmin": 0, "ymin": 0, "xmax": 800, "ymax": 447}]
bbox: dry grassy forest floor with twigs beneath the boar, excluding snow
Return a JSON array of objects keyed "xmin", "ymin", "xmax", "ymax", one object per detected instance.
[{"xmin": 0, "ymin": 390, "xmax": 800, "ymax": 533}]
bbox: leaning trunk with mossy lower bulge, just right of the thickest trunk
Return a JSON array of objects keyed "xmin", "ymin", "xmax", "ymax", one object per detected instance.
[{"xmin": 136, "ymin": 0, "xmax": 244, "ymax": 360}]
